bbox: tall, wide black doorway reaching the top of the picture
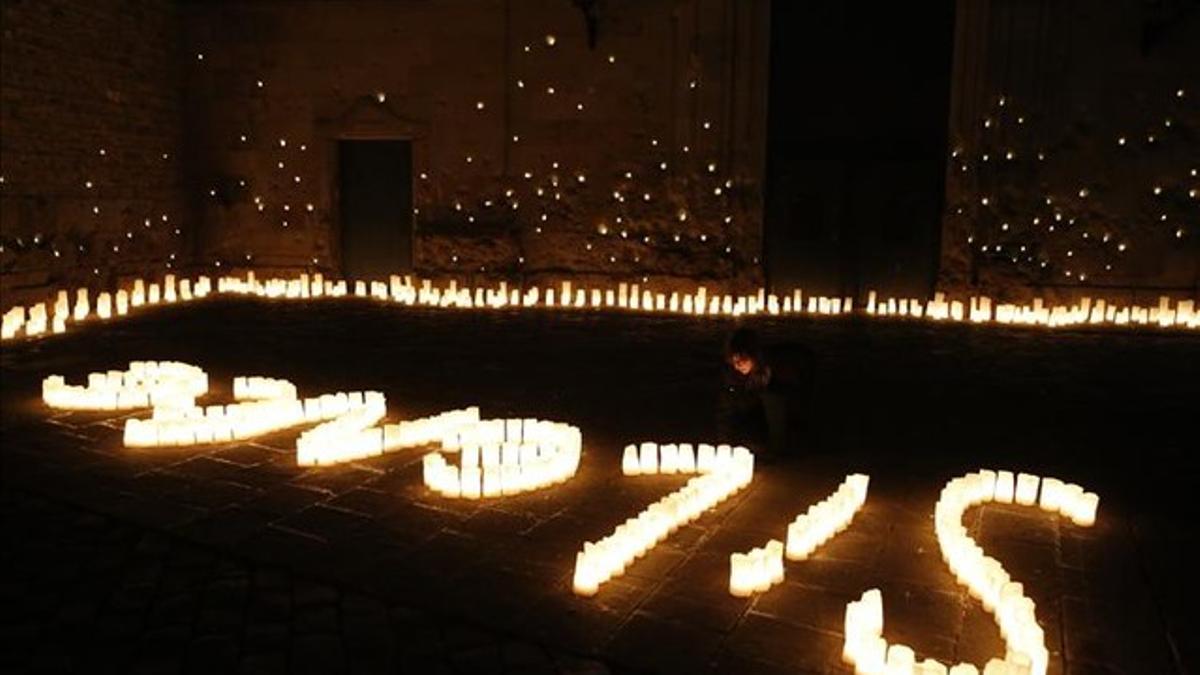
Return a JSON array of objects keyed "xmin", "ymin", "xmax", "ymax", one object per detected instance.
[{"xmin": 764, "ymin": 0, "xmax": 954, "ymax": 297}]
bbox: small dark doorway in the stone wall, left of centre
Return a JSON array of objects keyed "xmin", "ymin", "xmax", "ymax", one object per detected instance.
[{"xmin": 337, "ymin": 141, "xmax": 413, "ymax": 280}]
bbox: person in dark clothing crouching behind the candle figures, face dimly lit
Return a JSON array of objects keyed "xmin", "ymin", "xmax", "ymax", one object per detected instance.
[{"xmin": 718, "ymin": 327, "xmax": 812, "ymax": 458}]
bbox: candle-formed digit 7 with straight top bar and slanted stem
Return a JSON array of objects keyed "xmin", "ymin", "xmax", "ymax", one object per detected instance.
[{"xmin": 572, "ymin": 443, "xmax": 754, "ymax": 596}]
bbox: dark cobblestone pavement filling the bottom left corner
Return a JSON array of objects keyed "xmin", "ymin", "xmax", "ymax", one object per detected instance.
[{"xmin": 0, "ymin": 491, "xmax": 610, "ymax": 675}]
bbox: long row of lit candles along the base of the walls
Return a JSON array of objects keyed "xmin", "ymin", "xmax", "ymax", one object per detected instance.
[{"xmin": 0, "ymin": 271, "xmax": 1200, "ymax": 340}]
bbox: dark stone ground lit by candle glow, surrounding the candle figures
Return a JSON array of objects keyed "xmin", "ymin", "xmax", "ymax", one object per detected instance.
[{"xmin": 0, "ymin": 299, "xmax": 1200, "ymax": 674}]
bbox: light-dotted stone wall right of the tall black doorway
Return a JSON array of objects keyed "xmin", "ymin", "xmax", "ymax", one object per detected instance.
[{"xmin": 940, "ymin": 0, "xmax": 1200, "ymax": 299}]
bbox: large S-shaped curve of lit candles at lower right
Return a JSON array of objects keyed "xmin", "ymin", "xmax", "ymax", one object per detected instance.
[{"xmin": 842, "ymin": 470, "xmax": 1099, "ymax": 675}]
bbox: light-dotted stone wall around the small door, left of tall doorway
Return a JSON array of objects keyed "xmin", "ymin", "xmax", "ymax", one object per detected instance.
[{"xmin": 184, "ymin": 0, "xmax": 768, "ymax": 283}]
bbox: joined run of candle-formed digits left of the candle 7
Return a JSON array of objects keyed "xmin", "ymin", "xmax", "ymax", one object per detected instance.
[{"xmin": 42, "ymin": 362, "xmax": 583, "ymax": 498}]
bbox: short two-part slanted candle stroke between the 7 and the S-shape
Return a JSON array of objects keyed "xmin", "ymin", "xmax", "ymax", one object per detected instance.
[{"xmin": 730, "ymin": 473, "xmax": 870, "ymax": 598}]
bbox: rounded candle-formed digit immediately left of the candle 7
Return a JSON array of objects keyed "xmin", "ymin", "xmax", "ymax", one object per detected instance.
[{"xmin": 424, "ymin": 419, "xmax": 583, "ymax": 500}]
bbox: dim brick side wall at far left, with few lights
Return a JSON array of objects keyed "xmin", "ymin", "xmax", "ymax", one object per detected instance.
[{"xmin": 0, "ymin": 0, "xmax": 191, "ymax": 300}]
